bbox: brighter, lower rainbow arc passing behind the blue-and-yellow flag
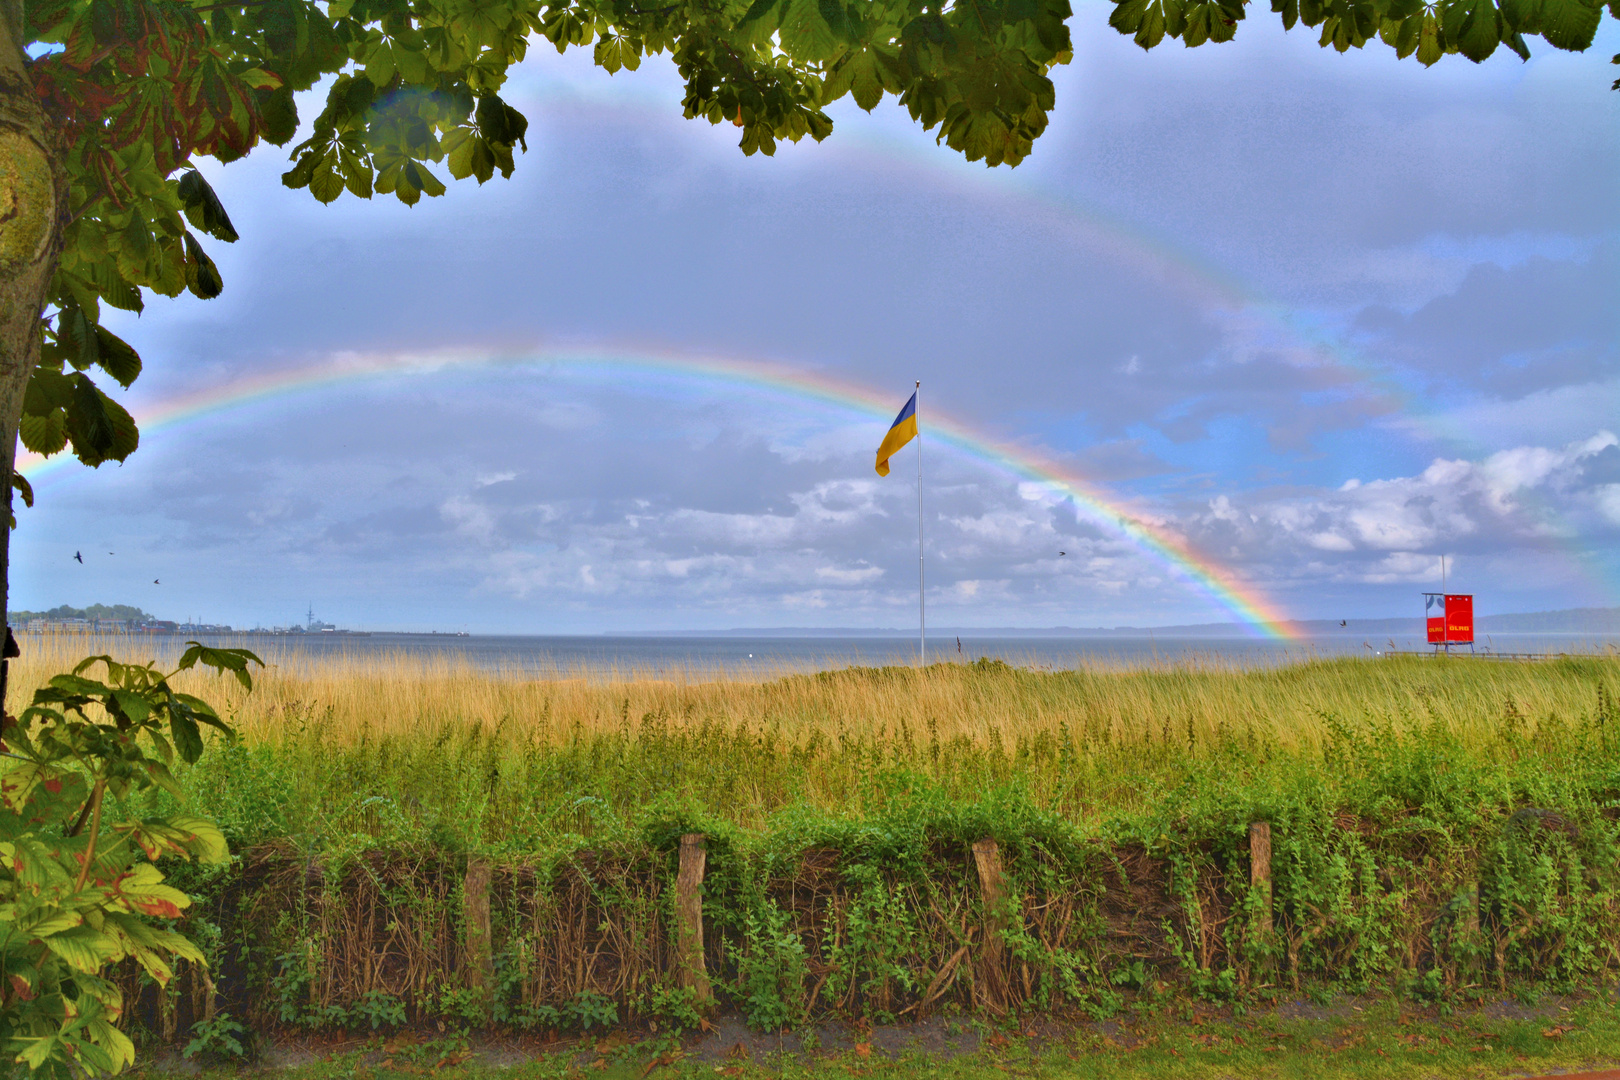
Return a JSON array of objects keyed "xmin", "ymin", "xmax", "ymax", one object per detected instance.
[{"xmin": 18, "ymin": 348, "xmax": 1296, "ymax": 640}]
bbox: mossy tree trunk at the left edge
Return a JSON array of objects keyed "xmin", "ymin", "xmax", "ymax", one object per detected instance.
[{"xmin": 0, "ymin": 0, "xmax": 70, "ymax": 706}]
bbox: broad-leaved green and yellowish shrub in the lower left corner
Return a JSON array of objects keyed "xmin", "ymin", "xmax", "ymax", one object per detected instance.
[{"xmin": 0, "ymin": 643, "xmax": 258, "ymax": 1077}]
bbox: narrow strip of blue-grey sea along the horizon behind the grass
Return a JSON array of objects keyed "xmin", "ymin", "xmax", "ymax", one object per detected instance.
[{"xmin": 85, "ymin": 633, "xmax": 1620, "ymax": 675}]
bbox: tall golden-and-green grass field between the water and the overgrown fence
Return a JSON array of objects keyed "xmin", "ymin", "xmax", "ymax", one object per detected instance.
[{"xmin": 11, "ymin": 638, "xmax": 1620, "ymax": 844}]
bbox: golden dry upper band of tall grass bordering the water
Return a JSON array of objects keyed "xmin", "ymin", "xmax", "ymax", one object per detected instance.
[{"xmin": 10, "ymin": 635, "xmax": 1620, "ymax": 753}]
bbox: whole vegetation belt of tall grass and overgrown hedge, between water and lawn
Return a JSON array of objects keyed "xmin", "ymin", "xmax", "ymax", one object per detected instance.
[{"xmin": 6, "ymin": 646, "xmax": 1620, "ymax": 1030}]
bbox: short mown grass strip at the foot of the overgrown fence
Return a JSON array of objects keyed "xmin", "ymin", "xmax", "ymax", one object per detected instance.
[{"xmin": 144, "ymin": 999, "xmax": 1620, "ymax": 1080}]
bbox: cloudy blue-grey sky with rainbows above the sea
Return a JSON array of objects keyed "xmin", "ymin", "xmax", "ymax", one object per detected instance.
[{"xmin": 11, "ymin": 12, "xmax": 1620, "ymax": 633}]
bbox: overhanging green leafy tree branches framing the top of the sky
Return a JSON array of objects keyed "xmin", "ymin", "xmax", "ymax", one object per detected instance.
[{"xmin": 21, "ymin": 0, "xmax": 1620, "ymax": 482}]
